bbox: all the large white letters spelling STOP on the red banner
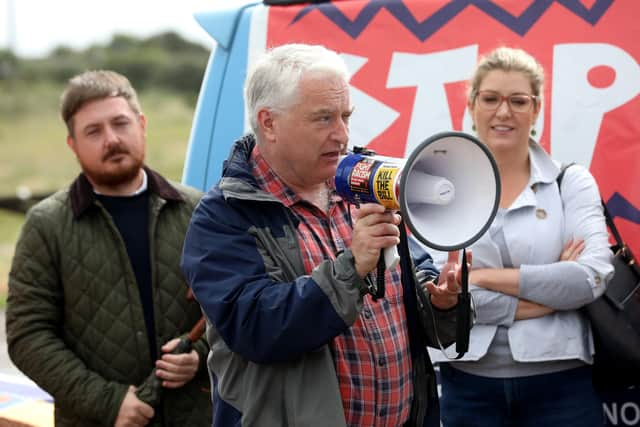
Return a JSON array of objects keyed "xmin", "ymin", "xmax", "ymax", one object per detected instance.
[{"xmin": 342, "ymin": 43, "xmax": 640, "ymax": 167}]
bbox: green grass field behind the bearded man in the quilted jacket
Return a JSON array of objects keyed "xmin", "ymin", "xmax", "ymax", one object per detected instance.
[{"xmin": 0, "ymin": 81, "xmax": 198, "ymax": 309}]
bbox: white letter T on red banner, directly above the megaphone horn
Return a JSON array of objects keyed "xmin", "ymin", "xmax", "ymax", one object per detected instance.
[{"xmin": 387, "ymin": 45, "xmax": 478, "ymax": 156}]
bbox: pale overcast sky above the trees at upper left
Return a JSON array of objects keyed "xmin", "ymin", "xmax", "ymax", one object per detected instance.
[{"xmin": 0, "ymin": 0, "xmax": 252, "ymax": 58}]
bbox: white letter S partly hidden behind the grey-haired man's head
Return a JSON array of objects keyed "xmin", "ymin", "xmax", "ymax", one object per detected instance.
[{"xmin": 340, "ymin": 53, "xmax": 400, "ymax": 148}]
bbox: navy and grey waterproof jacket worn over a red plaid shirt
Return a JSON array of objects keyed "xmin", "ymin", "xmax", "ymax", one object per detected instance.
[{"xmin": 182, "ymin": 136, "xmax": 455, "ymax": 426}]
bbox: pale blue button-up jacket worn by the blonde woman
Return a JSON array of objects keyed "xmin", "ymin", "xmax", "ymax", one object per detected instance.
[{"xmin": 430, "ymin": 141, "xmax": 613, "ymax": 363}]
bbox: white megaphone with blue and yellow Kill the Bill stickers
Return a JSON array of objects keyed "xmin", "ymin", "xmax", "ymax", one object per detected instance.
[{"xmin": 335, "ymin": 132, "xmax": 500, "ymax": 358}]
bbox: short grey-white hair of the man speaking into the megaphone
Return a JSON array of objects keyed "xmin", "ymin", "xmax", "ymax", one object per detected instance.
[{"xmin": 244, "ymin": 43, "xmax": 349, "ymax": 135}]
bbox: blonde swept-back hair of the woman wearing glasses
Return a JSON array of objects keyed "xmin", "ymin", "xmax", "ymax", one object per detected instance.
[{"xmin": 468, "ymin": 46, "xmax": 544, "ymax": 103}]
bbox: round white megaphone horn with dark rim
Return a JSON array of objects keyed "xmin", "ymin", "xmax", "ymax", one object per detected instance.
[{"xmin": 398, "ymin": 132, "xmax": 500, "ymax": 251}]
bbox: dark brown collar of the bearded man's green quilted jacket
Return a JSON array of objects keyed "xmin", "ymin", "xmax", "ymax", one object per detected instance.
[{"xmin": 69, "ymin": 166, "xmax": 184, "ymax": 218}]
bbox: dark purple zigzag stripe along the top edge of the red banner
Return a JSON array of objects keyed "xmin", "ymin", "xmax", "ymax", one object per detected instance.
[{"xmin": 290, "ymin": 0, "xmax": 613, "ymax": 41}]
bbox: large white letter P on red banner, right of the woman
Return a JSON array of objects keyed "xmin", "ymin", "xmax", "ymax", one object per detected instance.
[{"xmin": 551, "ymin": 43, "xmax": 640, "ymax": 167}]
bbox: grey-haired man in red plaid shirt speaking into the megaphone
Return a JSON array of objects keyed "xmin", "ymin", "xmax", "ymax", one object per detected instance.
[{"xmin": 182, "ymin": 44, "xmax": 470, "ymax": 427}]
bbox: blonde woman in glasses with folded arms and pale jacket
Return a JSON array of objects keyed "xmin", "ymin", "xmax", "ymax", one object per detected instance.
[{"xmin": 441, "ymin": 47, "xmax": 613, "ymax": 427}]
